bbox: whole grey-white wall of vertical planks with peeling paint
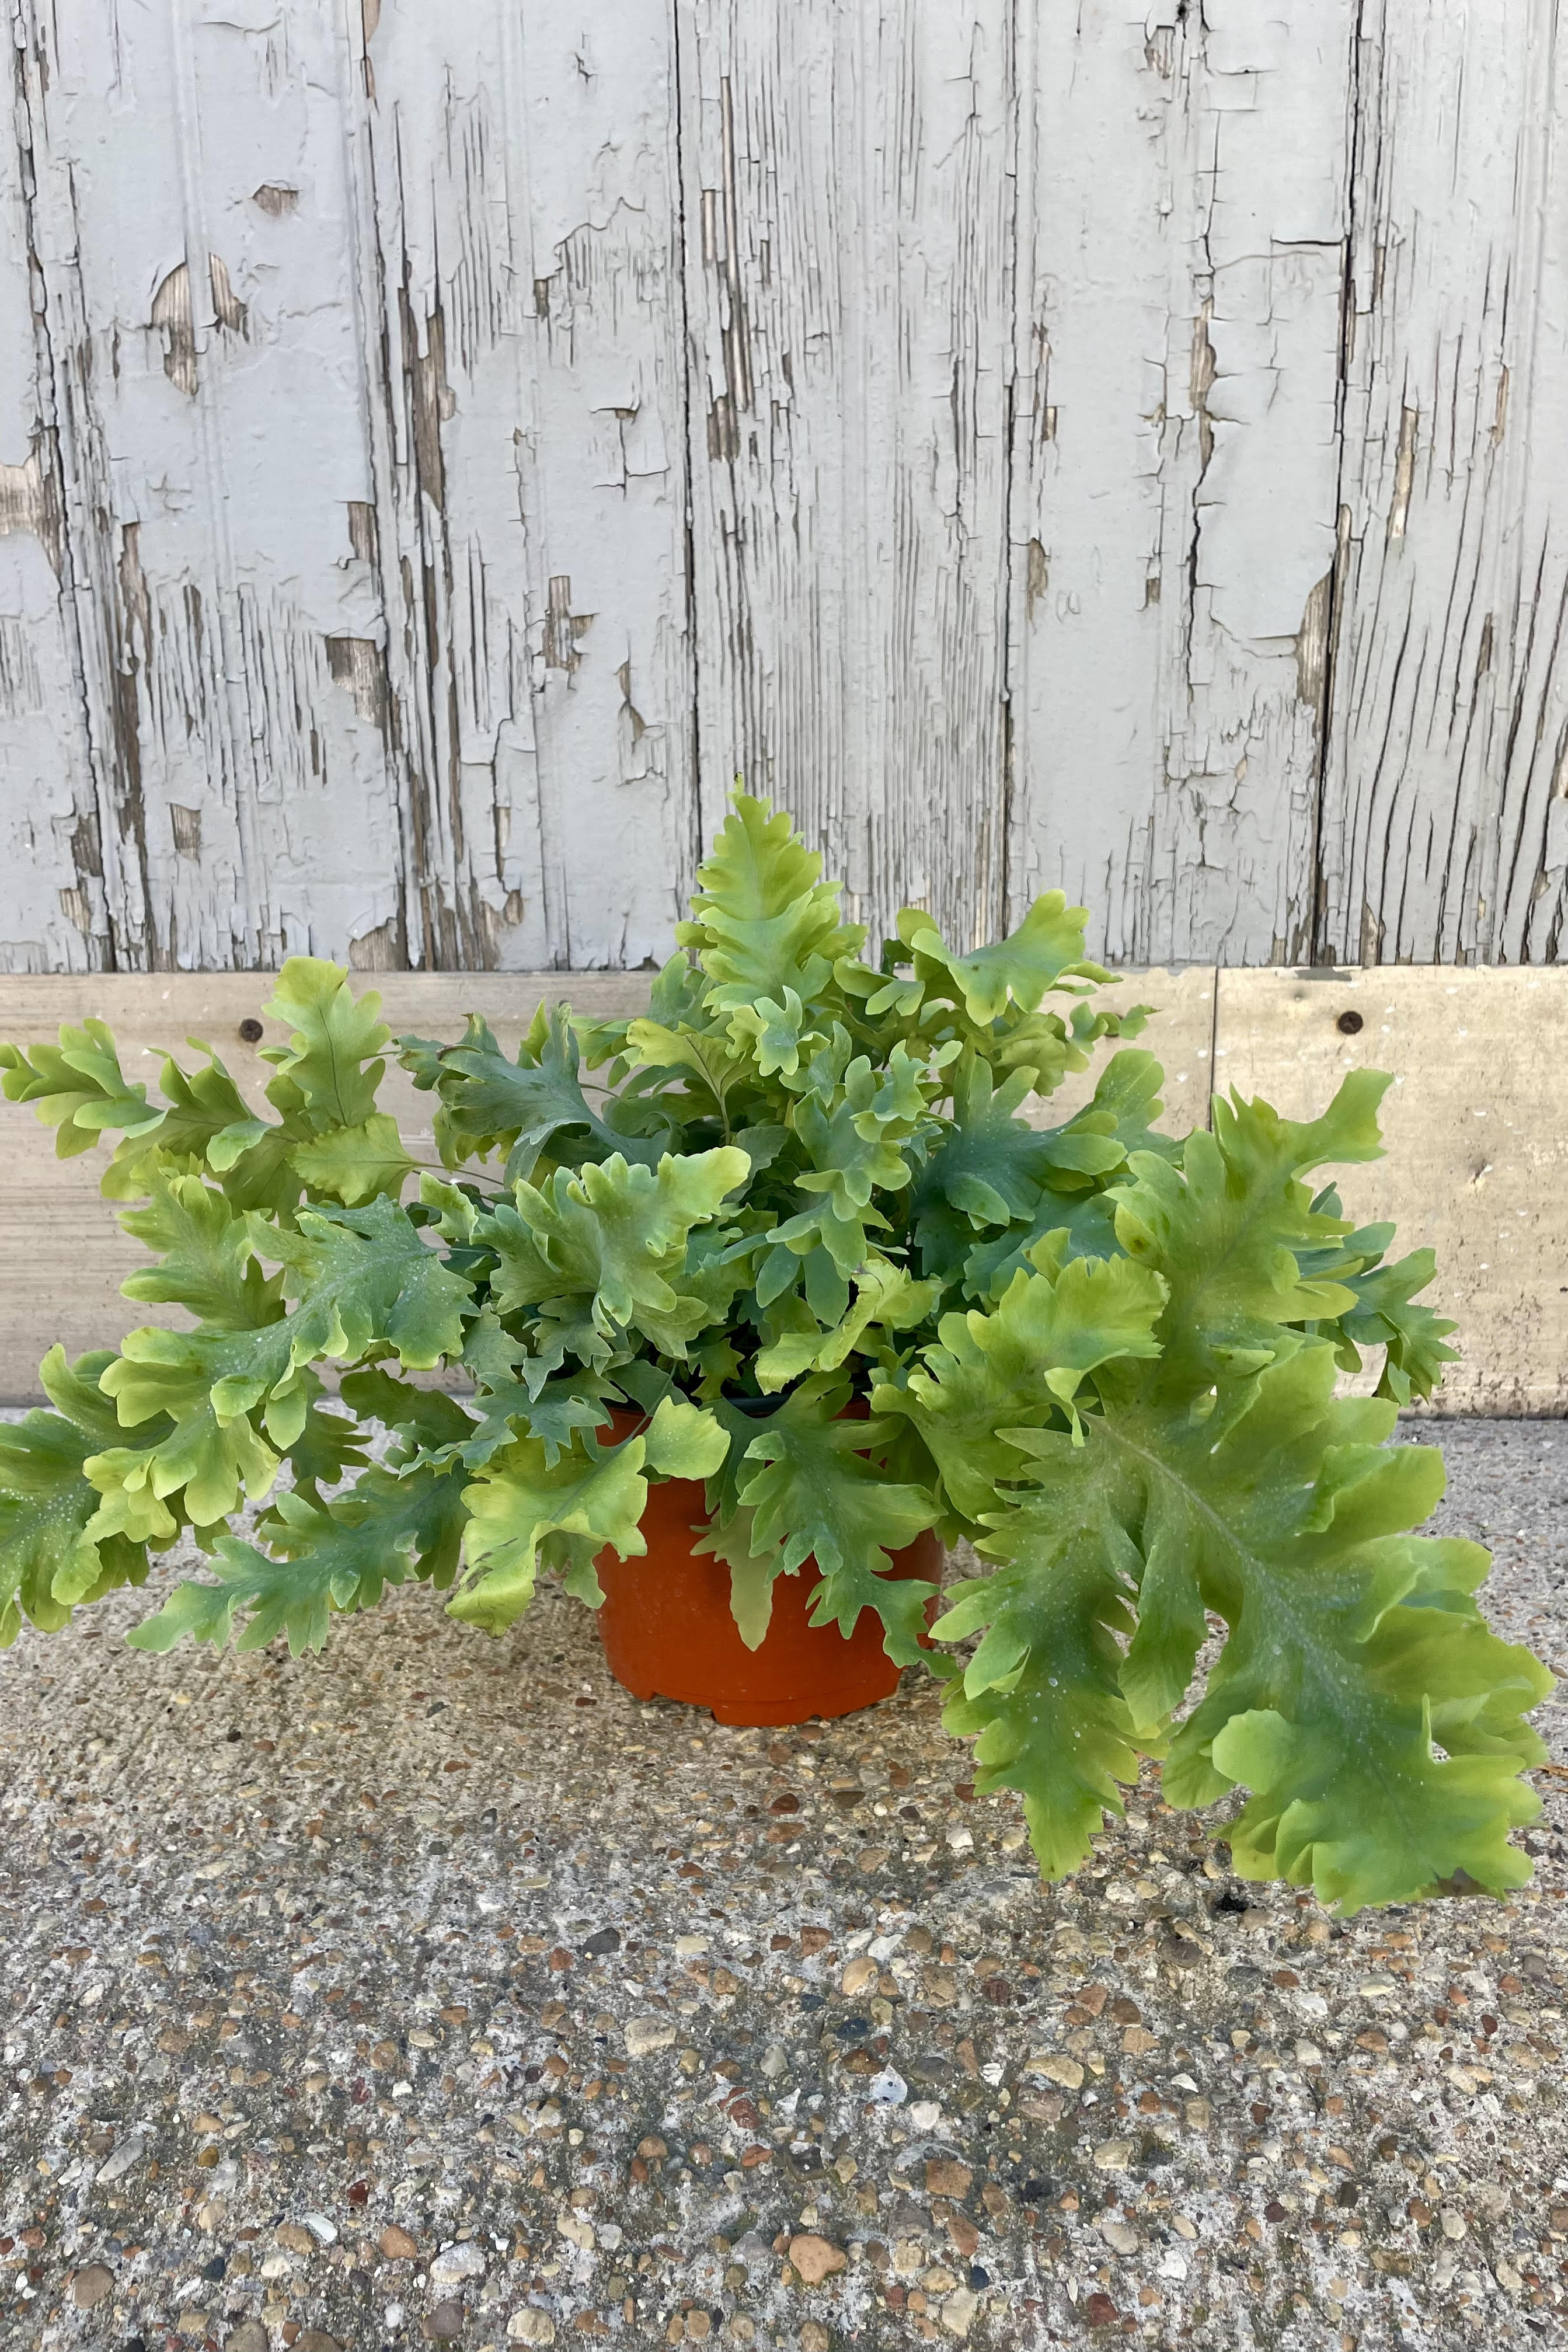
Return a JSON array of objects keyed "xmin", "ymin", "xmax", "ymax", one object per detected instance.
[{"xmin": 0, "ymin": 0, "xmax": 1568, "ymax": 974}]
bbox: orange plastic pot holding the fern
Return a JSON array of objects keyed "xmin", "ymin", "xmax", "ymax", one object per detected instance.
[{"xmin": 595, "ymin": 1413, "xmax": 943, "ymax": 1724}]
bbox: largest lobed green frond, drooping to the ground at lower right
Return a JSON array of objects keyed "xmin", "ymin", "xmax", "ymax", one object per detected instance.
[{"xmin": 985, "ymin": 1333, "xmax": 1549, "ymax": 1910}]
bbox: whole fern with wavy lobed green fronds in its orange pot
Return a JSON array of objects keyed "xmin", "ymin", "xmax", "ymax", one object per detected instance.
[{"xmin": 0, "ymin": 795, "xmax": 1549, "ymax": 1910}]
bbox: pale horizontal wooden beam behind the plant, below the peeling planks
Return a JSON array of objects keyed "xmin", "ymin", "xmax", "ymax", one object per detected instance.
[{"xmin": 0, "ymin": 964, "xmax": 1568, "ymax": 1413}]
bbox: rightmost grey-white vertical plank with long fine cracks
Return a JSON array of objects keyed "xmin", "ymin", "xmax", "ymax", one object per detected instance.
[{"xmin": 1319, "ymin": 0, "xmax": 1568, "ymax": 964}]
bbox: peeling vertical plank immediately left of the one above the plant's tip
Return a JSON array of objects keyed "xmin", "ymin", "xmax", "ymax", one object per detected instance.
[{"xmin": 350, "ymin": 0, "xmax": 696, "ymax": 969}]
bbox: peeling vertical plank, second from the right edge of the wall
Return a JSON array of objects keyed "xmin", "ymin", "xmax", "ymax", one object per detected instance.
[{"xmin": 1009, "ymin": 0, "xmax": 1354, "ymax": 962}]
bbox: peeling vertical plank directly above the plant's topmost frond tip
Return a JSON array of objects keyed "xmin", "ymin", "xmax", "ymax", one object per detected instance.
[{"xmin": 677, "ymin": 0, "xmax": 1011, "ymax": 946}]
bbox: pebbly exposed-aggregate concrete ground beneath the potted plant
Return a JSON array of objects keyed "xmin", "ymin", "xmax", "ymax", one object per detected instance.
[{"xmin": 0, "ymin": 1421, "xmax": 1568, "ymax": 2352}]
